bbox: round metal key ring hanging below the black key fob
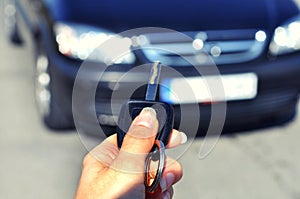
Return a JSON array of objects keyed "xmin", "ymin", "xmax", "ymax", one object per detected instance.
[{"xmin": 144, "ymin": 140, "xmax": 166, "ymax": 192}]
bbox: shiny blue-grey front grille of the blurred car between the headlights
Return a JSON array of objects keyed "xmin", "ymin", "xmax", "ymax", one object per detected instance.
[{"xmin": 141, "ymin": 29, "xmax": 267, "ymax": 66}]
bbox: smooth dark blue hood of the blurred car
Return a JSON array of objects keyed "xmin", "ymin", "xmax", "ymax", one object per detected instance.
[{"xmin": 44, "ymin": 0, "xmax": 299, "ymax": 32}]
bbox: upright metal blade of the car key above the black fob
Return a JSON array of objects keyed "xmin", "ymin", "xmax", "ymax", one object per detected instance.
[{"xmin": 145, "ymin": 61, "xmax": 161, "ymax": 101}]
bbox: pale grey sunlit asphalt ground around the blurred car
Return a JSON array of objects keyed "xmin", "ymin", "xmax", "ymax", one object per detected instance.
[{"xmin": 0, "ymin": 1, "xmax": 300, "ymax": 199}]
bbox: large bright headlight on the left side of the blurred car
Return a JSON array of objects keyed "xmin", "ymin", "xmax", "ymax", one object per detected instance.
[{"xmin": 54, "ymin": 22, "xmax": 135, "ymax": 64}]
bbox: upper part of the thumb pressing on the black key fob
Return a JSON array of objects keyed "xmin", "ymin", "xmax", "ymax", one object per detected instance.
[{"xmin": 120, "ymin": 107, "xmax": 158, "ymax": 154}]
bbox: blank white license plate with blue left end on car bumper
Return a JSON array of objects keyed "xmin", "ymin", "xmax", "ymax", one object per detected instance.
[{"xmin": 160, "ymin": 73, "xmax": 258, "ymax": 104}]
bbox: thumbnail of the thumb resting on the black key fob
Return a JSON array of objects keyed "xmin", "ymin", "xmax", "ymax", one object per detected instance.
[{"xmin": 134, "ymin": 107, "xmax": 156, "ymax": 128}]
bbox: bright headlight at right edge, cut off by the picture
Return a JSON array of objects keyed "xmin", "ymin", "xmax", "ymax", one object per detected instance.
[{"xmin": 269, "ymin": 16, "xmax": 300, "ymax": 56}]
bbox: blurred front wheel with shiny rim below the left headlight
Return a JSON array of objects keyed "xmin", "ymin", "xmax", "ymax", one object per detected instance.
[{"xmin": 35, "ymin": 46, "xmax": 74, "ymax": 130}]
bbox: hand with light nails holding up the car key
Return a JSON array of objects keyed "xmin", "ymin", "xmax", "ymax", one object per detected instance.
[{"xmin": 75, "ymin": 108, "xmax": 186, "ymax": 199}]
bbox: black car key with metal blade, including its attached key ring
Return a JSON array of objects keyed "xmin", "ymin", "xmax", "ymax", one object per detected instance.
[{"xmin": 117, "ymin": 62, "xmax": 174, "ymax": 192}]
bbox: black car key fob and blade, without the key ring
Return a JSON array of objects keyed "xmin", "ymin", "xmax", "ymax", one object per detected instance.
[{"xmin": 117, "ymin": 61, "xmax": 174, "ymax": 151}]
